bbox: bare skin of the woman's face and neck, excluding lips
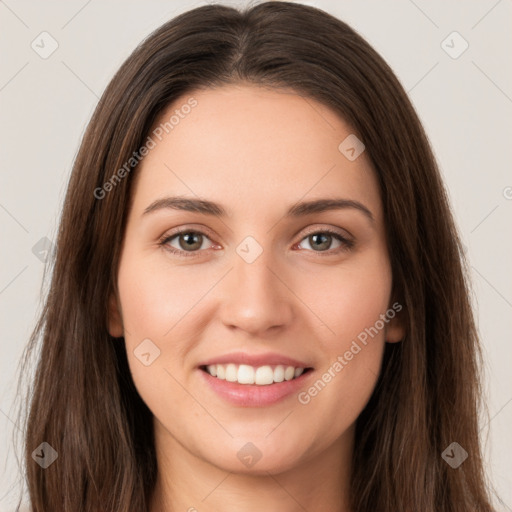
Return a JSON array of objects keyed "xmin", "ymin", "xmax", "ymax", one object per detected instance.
[{"xmin": 109, "ymin": 85, "xmax": 404, "ymax": 512}]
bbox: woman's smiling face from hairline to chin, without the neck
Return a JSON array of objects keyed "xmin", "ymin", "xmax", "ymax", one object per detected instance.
[{"xmin": 109, "ymin": 86, "xmax": 403, "ymax": 473}]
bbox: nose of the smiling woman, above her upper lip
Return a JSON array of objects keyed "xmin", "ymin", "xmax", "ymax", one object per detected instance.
[{"xmin": 220, "ymin": 243, "xmax": 295, "ymax": 337}]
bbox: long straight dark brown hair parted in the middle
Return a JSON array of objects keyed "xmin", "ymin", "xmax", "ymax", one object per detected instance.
[{"xmin": 14, "ymin": 2, "xmax": 492, "ymax": 512}]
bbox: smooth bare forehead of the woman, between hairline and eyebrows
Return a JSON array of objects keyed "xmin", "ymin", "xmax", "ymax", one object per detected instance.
[{"xmin": 130, "ymin": 85, "xmax": 380, "ymax": 217}]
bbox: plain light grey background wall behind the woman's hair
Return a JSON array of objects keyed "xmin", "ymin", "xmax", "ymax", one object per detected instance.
[{"xmin": 0, "ymin": 0, "xmax": 512, "ymax": 512}]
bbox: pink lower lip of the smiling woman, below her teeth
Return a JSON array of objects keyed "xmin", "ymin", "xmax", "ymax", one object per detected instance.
[{"xmin": 198, "ymin": 369, "xmax": 313, "ymax": 407}]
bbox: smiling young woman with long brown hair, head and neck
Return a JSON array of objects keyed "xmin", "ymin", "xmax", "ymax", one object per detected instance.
[{"xmin": 15, "ymin": 2, "xmax": 492, "ymax": 512}]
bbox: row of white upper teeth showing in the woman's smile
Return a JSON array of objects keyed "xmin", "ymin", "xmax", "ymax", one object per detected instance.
[{"xmin": 206, "ymin": 363, "xmax": 304, "ymax": 386}]
